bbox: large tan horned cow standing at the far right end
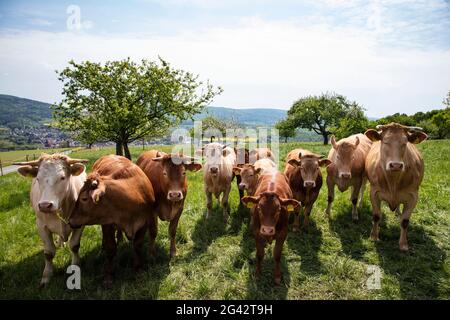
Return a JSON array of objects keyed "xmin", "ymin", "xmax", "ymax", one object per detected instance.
[{"xmin": 365, "ymin": 123, "xmax": 427, "ymax": 251}]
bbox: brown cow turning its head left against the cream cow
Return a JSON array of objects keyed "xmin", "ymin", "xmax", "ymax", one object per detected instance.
[{"xmin": 69, "ymin": 155, "xmax": 155, "ymax": 287}]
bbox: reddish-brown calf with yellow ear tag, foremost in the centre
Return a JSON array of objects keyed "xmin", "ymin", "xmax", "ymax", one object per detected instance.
[{"xmin": 242, "ymin": 171, "xmax": 300, "ymax": 284}]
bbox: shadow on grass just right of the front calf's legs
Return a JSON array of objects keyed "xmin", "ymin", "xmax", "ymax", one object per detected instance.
[{"xmin": 287, "ymin": 215, "xmax": 324, "ymax": 275}]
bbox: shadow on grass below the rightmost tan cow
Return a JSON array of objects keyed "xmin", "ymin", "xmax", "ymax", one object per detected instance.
[{"xmin": 376, "ymin": 219, "xmax": 449, "ymax": 299}]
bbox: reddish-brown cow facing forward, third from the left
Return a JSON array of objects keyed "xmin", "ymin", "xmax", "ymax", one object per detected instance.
[{"xmin": 136, "ymin": 150, "xmax": 202, "ymax": 257}]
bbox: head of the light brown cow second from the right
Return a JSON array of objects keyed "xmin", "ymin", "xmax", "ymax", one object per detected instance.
[{"xmin": 331, "ymin": 136, "xmax": 359, "ymax": 180}]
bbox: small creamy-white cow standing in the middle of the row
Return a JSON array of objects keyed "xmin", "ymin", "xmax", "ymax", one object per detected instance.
[{"xmin": 197, "ymin": 142, "xmax": 236, "ymax": 222}]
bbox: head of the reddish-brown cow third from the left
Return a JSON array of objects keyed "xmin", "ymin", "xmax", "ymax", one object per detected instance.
[{"xmin": 152, "ymin": 154, "xmax": 202, "ymax": 202}]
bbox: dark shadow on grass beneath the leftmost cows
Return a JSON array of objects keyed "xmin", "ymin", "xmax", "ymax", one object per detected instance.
[{"xmin": 0, "ymin": 236, "xmax": 170, "ymax": 299}]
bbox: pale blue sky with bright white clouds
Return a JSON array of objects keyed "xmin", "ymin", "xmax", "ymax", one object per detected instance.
[{"xmin": 0, "ymin": 0, "xmax": 450, "ymax": 116}]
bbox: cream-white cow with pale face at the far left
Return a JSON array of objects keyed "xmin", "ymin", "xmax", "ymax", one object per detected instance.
[{"xmin": 15, "ymin": 154, "xmax": 88, "ymax": 287}]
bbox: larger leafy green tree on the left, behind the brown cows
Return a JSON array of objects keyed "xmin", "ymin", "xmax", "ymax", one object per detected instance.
[{"xmin": 52, "ymin": 58, "xmax": 222, "ymax": 159}]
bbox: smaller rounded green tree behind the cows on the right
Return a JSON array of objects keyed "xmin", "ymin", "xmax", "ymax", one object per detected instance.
[{"xmin": 288, "ymin": 93, "xmax": 367, "ymax": 145}]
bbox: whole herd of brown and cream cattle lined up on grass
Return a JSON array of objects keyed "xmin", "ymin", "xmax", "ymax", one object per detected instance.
[{"xmin": 13, "ymin": 123, "xmax": 427, "ymax": 286}]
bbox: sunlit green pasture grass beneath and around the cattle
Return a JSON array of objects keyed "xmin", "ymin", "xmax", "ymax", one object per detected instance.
[{"xmin": 0, "ymin": 140, "xmax": 450, "ymax": 299}]
